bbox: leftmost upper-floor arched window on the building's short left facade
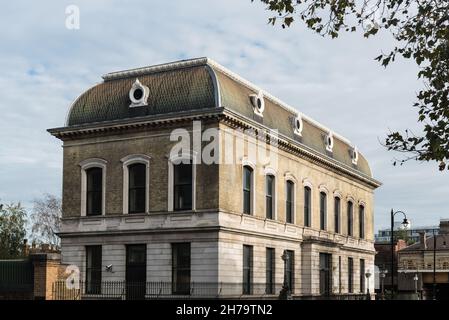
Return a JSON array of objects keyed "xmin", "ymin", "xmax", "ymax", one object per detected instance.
[{"xmin": 86, "ymin": 167, "xmax": 103, "ymax": 216}]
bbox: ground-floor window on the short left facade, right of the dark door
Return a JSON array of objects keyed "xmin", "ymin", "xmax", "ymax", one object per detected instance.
[{"xmin": 172, "ymin": 243, "xmax": 190, "ymax": 294}]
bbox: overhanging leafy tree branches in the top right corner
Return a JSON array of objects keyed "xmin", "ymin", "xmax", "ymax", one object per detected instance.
[{"xmin": 251, "ymin": 0, "xmax": 449, "ymax": 170}]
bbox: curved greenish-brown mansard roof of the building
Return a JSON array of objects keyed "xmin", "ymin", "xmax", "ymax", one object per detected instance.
[{"xmin": 66, "ymin": 58, "xmax": 372, "ymax": 177}]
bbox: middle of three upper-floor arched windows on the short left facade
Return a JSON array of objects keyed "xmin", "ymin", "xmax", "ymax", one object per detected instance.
[{"xmin": 128, "ymin": 163, "xmax": 146, "ymax": 213}]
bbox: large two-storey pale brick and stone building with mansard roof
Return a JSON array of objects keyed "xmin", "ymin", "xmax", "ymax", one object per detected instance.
[{"xmin": 49, "ymin": 58, "xmax": 380, "ymax": 297}]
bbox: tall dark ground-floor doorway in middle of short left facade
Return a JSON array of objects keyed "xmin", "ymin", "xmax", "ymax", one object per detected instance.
[{"xmin": 126, "ymin": 244, "xmax": 147, "ymax": 300}]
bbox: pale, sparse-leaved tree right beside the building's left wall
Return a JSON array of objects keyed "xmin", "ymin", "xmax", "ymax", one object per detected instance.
[{"xmin": 31, "ymin": 193, "xmax": 62, "ymax": 246}]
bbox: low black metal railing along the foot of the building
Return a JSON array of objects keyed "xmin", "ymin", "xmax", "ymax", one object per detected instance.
[{"xmin": 53, "ymin": 281, "xmax": 366, "ymax": 300}]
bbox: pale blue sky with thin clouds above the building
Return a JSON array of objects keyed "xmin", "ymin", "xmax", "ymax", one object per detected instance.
[{"xmin": 0, "ymin": 0, "xmax": 449, "ymax": 230}]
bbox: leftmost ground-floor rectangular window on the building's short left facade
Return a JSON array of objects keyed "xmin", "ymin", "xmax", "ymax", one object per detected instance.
[{"xmin": 86, "ymin": 246, "xmax": 102, "ymax": 294}]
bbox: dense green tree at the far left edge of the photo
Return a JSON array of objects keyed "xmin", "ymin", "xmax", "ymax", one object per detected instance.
[{"xmin": 0, "ymin": 202, "xmax": 27, "ymax": 259}]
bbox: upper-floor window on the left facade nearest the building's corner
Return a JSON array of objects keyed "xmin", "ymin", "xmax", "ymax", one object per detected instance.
[{"xmin": 173, "ymin": 163, "xmax": 193, "ymax": 210}]
